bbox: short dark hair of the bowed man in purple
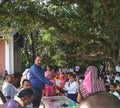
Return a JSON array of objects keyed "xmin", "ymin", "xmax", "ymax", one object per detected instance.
[{"xmin": 18, "ymin": 88, "xmax": 34, "ymax": 98}]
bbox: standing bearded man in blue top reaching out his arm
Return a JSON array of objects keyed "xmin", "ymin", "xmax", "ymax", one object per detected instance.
[{"xmin": 30, "ymin": 56, "xmax": 53, "ymax": 108}]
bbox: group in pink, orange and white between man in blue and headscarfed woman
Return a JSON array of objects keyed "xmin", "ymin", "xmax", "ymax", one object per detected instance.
[{"xmin": 43, "ymin": 66, "xmax": 78, "ymax": 102}]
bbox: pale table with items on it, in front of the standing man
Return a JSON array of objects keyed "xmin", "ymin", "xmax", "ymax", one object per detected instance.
[{"xmin": 41, "ymin": 96, "xmax": 78, "ymax": 108}]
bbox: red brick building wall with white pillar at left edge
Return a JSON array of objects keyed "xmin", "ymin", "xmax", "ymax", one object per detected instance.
[{"xmin": 0, "ymin": 35, "xmax": 22, "ymax": 77}]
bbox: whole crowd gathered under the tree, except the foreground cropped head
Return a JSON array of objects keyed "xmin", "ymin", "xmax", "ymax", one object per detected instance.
[{"xmin": 2, "ymin": 56, "xmax": 120, "ymax": 108}]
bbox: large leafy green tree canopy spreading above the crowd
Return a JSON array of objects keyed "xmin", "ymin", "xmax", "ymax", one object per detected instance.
[{"xmin": 0, "ymin": 0, "xmax": 120, "ymax": 69}]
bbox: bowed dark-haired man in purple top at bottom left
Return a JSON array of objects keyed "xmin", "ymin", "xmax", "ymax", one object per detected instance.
[{"xmin": 3, "ymin": 88, "xmax": 34, "ymax": 108}]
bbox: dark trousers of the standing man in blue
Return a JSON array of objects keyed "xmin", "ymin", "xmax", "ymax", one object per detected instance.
[{"xmin": 33, "ymin": 88, "xmax": 42, "ymax": 108}]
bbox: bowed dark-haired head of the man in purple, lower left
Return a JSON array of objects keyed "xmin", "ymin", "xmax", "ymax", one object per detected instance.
[{"xmin": 18, "ymin": 88, "xmax": 34, "ymax": 106}]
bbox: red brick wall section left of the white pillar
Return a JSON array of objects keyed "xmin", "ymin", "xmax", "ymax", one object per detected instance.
[{"xmin": 0, "ymin": 41, "xmax": 5, "ymax": 77}]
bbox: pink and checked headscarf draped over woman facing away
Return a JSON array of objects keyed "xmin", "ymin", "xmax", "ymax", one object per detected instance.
[{"xmin": 80, "ymin": 66, "xmax": 105, "ymax": 98}]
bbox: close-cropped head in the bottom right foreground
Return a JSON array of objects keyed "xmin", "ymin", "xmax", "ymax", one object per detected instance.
[{"xmin": 79, "ymin": 92, "xmax": 120, "ymax": 108}]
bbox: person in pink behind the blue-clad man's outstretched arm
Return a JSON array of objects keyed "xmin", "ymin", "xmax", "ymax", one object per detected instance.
[{"xmin": 45, "ymin": 66, "xmax": 55, "ymax": 96}]
